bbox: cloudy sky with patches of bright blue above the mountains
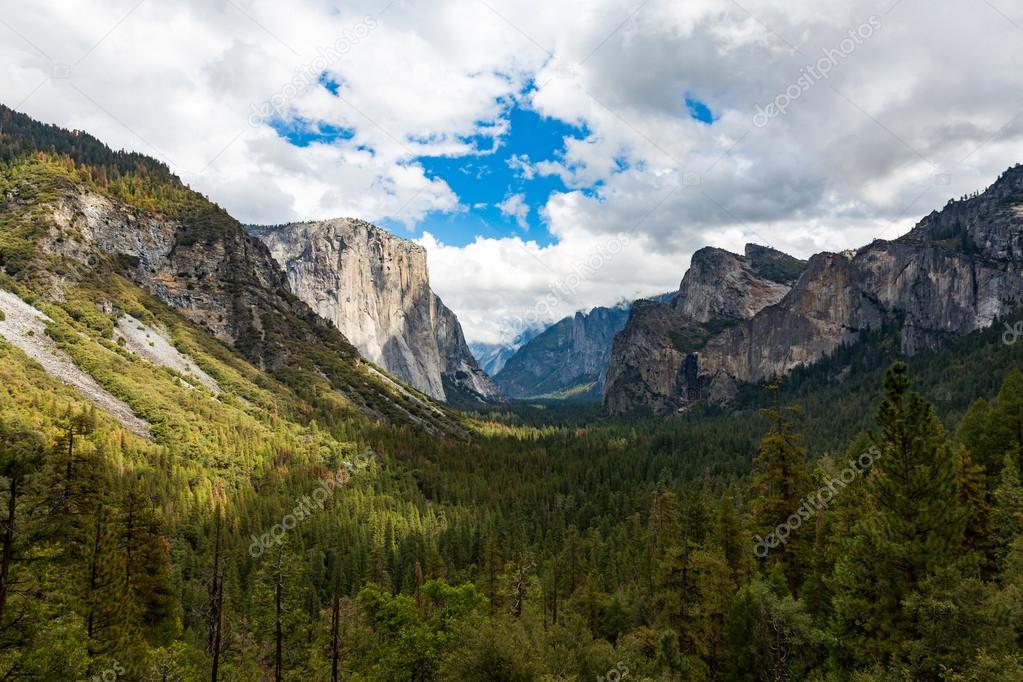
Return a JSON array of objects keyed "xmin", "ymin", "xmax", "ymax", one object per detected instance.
[{"xmin": 0, "ymin": 0, "xmax": 1023, "ymax": 343}]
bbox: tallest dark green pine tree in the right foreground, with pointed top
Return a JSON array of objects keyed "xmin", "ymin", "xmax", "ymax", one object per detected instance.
[{"xmin": 834, "ymin": 363, "xmax": 967, "ymax": 662}]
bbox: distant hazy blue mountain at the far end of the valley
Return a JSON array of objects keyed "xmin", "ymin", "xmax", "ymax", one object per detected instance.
[{"xmin": 494, "ymin": 305, "xmax": 629, "ymax": 399}]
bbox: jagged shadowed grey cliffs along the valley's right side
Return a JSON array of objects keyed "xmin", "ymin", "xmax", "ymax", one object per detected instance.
[{"xmin": 605, "ymin": 166, "xmax": 1023, "ymax": 414}]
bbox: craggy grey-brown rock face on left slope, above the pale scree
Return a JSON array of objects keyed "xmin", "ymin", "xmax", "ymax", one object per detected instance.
[{"xmin": 36, "ymin": 184, "xmax": 329, "ymax": 369}]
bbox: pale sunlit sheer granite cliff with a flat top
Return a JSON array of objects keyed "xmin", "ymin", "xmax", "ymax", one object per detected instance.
[{"xmin": 248, "ymin": 219, "xmax": 498, "ymax": 400}]
